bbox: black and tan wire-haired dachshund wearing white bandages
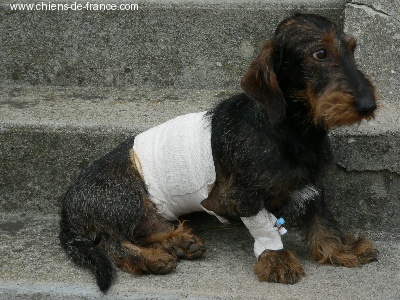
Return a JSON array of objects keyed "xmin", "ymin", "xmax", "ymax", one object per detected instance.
[{"xmin": 60, "ymin": 14, "xmax": 378, "ymax": 292}]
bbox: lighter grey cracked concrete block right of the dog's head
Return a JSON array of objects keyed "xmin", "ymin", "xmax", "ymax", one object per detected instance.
[{"xmin": 344, "ymin": 0, "xmax": 400, "ymax": 106}]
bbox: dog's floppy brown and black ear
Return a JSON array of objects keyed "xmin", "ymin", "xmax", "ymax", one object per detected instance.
[{"xmin": 241, "ymin": 41, "xmax": 286, "ymax": 126}]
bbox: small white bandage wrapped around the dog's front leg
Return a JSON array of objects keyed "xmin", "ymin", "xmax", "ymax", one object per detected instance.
[{"xmin": 241, "ymin": 208, "xmax": 283, "ymax": 258}]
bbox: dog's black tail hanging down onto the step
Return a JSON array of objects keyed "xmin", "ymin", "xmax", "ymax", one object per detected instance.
[{"xmin": 60, "ymin": 216, "xmax": 115, "ymax": 293}]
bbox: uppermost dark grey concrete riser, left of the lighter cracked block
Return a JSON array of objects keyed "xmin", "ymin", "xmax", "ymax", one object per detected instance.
[{"xmin": 0, "ymin": 0, "xmax": 346, "ymax": 89}]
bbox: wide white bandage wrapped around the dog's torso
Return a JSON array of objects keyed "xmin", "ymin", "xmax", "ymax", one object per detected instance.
[{"xmin": 133, "ymin": 112, "xmax": 216, "ymax": 220}]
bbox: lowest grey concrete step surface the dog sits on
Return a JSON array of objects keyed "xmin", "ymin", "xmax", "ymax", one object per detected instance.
[{"xmin": 0, "ymin": 212, "xmax": 400, "ymax": 300}]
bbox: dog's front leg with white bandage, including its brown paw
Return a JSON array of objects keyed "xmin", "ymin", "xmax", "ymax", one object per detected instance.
[{"xmin": 241, "ymin": 209, "xmax": 305, "ymax": 284}]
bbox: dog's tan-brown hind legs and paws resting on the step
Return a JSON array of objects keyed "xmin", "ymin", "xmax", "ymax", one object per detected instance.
[{"xmin": 99, "ymin": 205, "xmax": 205, "ymax": 274}]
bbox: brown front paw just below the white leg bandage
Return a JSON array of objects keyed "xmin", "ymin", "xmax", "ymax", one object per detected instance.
[{"xmin": 254, "ymin": 250, "xmax": 305, "ymax": 284}]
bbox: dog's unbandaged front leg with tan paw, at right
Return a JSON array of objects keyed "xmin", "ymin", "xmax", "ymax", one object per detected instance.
[{"xmin": 303, "ymin": 189, "xmax": 378, "ymax": 267}]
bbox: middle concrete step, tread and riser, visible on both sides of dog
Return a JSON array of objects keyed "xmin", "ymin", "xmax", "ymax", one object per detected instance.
[{"xmin": 0, "ymin": 86, "xmax": 400, "ymax": 231}]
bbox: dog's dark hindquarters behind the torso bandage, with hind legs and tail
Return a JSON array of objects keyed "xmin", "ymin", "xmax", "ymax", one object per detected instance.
[{"xmin": 59, "ymin": 140, "xmax": 204, "ymax": 292}]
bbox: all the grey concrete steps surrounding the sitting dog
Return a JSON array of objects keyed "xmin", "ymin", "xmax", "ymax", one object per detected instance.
[{"xmin": 0, "ymin": 0, "xmax": 400, "ymax": 300}]
